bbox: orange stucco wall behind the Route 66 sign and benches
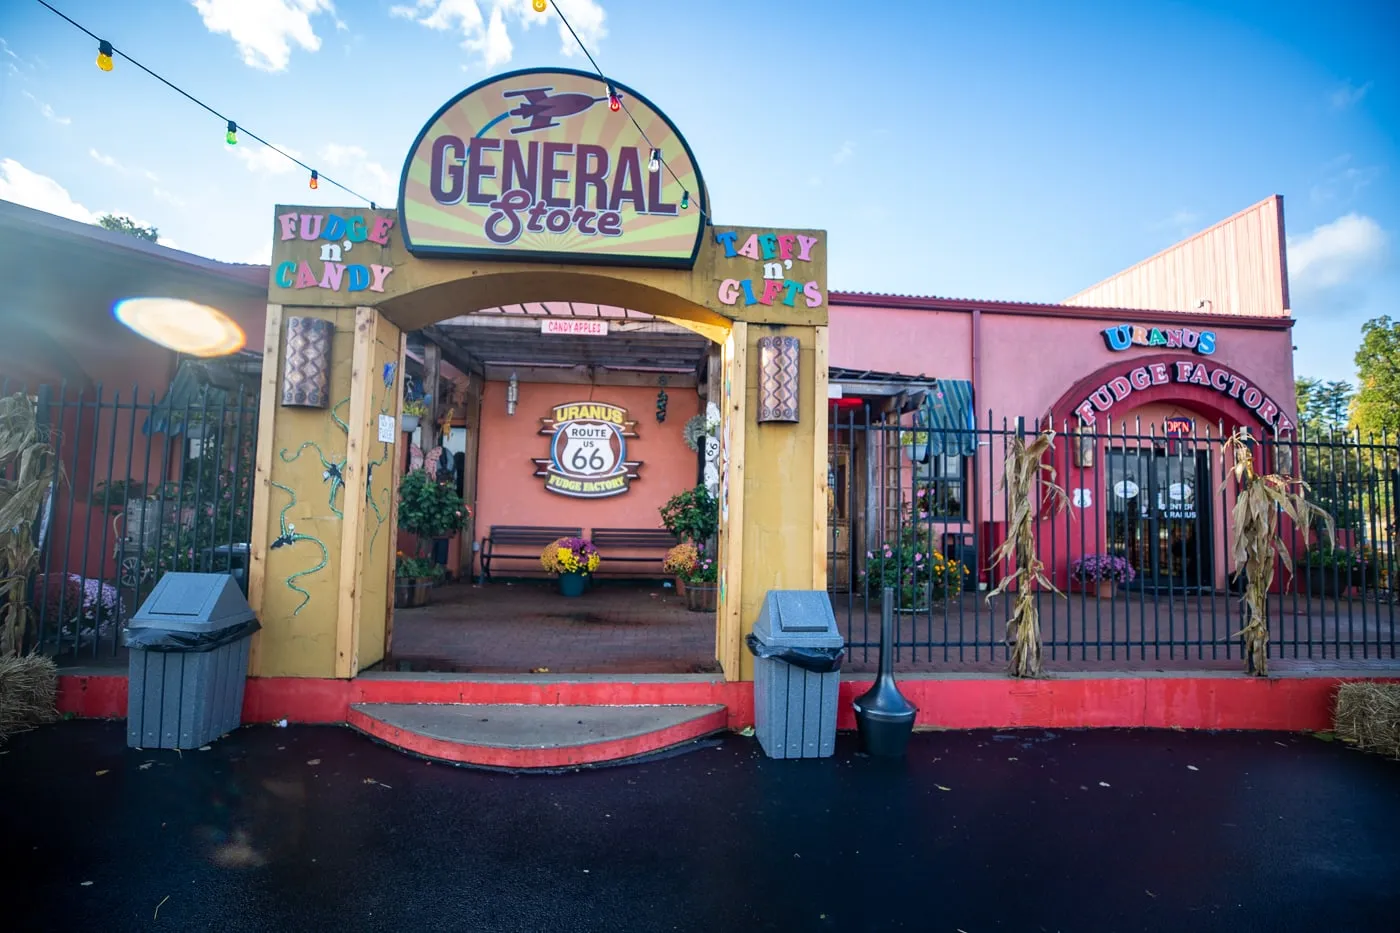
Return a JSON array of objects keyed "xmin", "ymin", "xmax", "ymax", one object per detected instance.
[{"xmin": 476, "ymin": 382, "xmax": 700, "ymax": 576}]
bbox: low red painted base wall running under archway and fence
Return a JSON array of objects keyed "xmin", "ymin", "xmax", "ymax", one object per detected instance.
[{"xmin": 51, "ymin": 675, "xmax": 1392, "ymax": 731}]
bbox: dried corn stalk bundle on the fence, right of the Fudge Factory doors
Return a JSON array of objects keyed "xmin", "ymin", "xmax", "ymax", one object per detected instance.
[{"xmin": 1221, "ymin": 431, "xmax": 1333, "ymax": 677}]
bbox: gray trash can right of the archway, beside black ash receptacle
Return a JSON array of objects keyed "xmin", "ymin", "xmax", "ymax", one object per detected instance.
[{"xmin": 748, "ymin": 590, "xmax": 846, "ymax": 758}]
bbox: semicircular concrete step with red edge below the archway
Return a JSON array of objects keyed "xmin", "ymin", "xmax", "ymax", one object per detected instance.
[{"xmin": 349, "ymin": 703, "xmax": 728, "ymax": 770}]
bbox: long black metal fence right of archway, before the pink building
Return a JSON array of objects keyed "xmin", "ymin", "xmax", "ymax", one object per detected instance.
[{"xmin": 827, "ymin": 405, "xmax": 1400, "ymax": 670}]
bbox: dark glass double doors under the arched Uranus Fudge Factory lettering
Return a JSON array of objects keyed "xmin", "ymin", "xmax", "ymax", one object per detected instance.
[{"xmin": 1105, "ymin": 444, "xmax": 1214, "ymax": 593}]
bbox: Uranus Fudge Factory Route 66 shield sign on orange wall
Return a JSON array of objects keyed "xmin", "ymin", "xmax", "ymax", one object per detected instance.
[{"xmin": 532, "ymin": 402, "xmax": 641, "ymax": 499}]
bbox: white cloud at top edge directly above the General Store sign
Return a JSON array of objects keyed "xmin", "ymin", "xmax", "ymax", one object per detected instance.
[{"xmin": 389, "ymin": 0, "xmax": 608, "ymax": 67}]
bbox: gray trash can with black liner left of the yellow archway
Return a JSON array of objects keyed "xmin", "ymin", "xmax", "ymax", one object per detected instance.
[{"xmin": 126, "ymin": 573, "xmax": 259, "ymax": 748}]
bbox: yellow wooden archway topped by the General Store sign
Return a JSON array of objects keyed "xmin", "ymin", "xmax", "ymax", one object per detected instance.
[{"xmin": 249, "ymin": 63, "xmax": 827, "ymax": 679}]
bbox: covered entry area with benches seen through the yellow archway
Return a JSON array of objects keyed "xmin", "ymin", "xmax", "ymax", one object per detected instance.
[{"xmin": 381, "ymin": 301, "xmax": 721, "ymax": 674}]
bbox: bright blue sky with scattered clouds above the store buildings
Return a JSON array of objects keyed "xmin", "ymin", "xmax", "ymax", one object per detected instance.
[{"xmin": 0, "ymin": 0, "xmax": 1400, "ymax": 378}]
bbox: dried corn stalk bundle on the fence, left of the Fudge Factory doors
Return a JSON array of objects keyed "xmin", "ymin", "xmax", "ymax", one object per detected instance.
[{"xmin": 987, "ymin": 430, "xmax": 1068, "ymax": 677}]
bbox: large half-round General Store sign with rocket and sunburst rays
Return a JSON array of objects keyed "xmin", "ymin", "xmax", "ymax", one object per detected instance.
[{"xmin": 399, "ymin": 69, "xmax": 707, "ymax": 269}]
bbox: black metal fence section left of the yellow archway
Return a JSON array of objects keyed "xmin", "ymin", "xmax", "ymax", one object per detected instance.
[{"xmin": 0, "ymin": 370, "xmax": 258, "ymax": 663}]
